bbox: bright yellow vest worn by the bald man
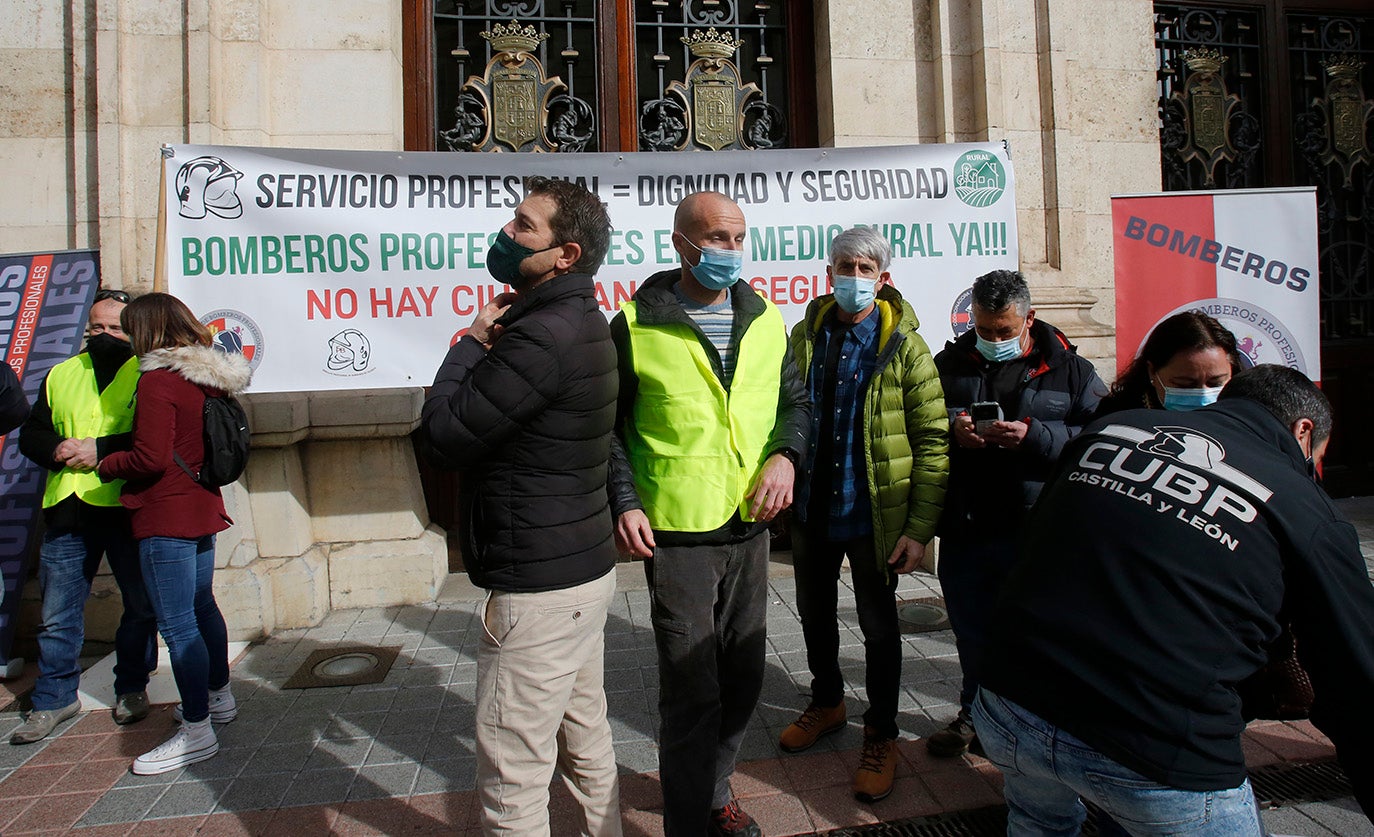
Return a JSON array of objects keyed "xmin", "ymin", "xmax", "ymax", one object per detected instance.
[{"xmin": 622, "ymin": 302, "xmax": 787, "ymax": 532}]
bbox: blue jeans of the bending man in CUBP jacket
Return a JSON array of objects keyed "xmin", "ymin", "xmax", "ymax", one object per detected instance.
[{"xmin": 973, "ymin": 689, "xmax": 1265, "ymax": 837}]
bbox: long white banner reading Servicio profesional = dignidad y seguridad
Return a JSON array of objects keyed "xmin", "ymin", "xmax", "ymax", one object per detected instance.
[{"xmin": 161, "ymin": 143, "xmax": 1017, "ymax": 392}]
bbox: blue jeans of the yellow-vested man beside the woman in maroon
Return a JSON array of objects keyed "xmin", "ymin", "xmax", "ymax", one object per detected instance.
[{"xmin": 33, "ymin": 529, "xmax": 158, "ymax": 709}]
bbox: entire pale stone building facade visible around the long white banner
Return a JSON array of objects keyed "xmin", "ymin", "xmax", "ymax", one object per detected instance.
[{"xmin": 0, "ymin": 0, "xmax": 1160, "ymax": 638}]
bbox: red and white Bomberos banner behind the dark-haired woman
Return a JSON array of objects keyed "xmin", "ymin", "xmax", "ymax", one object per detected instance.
[{"xmin": 1112, "ymin": 187, "xmax": 1322, "ymax": 381}]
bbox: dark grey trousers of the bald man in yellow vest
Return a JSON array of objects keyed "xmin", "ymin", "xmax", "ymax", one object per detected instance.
[{"xmin": 644, "ymin": 532, "xmax": 768, "ymax": 837}]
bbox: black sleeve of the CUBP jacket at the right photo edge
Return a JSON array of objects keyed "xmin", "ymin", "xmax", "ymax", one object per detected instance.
[{"xmin": 1286, "ymin": 521, "xmax": 1374, "ymax": 821}]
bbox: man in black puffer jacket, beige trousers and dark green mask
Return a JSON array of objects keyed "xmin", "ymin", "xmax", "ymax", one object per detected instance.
[{"xmin": 423, "ymin": 177, "xmax": 621, "ymax": 836}]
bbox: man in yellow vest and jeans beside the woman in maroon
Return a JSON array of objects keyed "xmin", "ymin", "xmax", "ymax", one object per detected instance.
[{"xmin": 10, "ymin": 290, "xmax": 158, "ymax": 744}]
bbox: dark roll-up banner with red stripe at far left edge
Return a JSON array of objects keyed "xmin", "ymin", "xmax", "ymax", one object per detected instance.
[{"xmin": 0, "ymin": 250, "xmax": 100, "ymax": 676}]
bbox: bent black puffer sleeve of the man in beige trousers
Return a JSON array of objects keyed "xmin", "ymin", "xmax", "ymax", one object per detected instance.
[{"xmin": 420, "ymin": 324, "xmax": 559, "ymax": 469}]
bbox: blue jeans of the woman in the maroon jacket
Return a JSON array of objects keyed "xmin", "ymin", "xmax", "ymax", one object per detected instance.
[{"xmin": 139, "ymin": 535, "xmax": 229, "ymax": 722}]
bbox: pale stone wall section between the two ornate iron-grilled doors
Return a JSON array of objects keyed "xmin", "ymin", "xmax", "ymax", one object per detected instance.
[{"xmin": 816, "ymin": 0, "xmax": 1160, "ymax": 379}]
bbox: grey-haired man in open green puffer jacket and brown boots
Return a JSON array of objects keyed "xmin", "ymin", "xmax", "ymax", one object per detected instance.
[{"xmin": 779, "ymin": 227, "xmax": 949, "ymax": 803}]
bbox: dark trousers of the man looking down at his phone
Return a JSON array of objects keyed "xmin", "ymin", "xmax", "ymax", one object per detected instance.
[{"xmin": 937, "ymin": 537, "xmax": 1017, "ymax": 712}]
